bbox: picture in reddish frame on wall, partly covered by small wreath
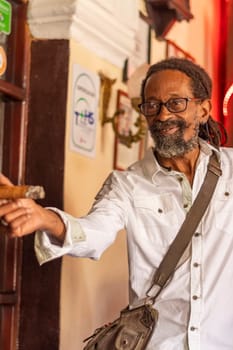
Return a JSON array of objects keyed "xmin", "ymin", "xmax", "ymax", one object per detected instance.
[{"xmin": 114, "ymin": 90, "xmax": 144, "ymax": 170}]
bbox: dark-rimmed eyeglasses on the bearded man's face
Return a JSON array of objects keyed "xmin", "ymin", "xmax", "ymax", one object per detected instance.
[{"xmin": 138, "ymin": 97, "xmax": 201, "ymax": 117}]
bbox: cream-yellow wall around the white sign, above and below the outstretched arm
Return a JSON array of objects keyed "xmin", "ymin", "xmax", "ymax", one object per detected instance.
[{"xmin": 61, "ymin": 41, "xmax": 128, "ymax": 350}]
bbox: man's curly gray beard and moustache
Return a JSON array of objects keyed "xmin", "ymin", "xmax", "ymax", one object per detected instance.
[{"xmin": 149, "ymin": 120, "xmax": 199, "ymax": 158}]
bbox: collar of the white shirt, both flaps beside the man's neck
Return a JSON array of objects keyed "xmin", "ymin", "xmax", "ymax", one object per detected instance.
[{"xmin": 141, "ymin": 138, "xmax": 220, "ymax": 181}]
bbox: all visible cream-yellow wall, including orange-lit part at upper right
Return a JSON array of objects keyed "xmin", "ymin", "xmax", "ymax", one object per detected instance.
[{"xmin": 60, "ymin": 0, "xmax": 216, "ymax": 350}]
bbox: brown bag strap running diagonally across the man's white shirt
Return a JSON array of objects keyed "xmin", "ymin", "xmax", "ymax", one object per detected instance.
[{"xmin": 147, "ymin": 152, "xmax": 222, "ymax": 300}]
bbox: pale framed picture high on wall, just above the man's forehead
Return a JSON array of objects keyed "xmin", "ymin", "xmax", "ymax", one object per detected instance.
[{"xmin": 123, "ymin": 12, "xmax": 151, "ymax": 82}]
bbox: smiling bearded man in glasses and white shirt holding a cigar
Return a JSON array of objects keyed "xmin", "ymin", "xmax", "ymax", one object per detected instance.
[{"xmin": 0, "ymin": 58, "xmax": 233, "ymax": 350}]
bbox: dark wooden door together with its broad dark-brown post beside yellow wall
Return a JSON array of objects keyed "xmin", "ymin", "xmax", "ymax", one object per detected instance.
[{"xmin": 0, "ymin": 0, "xmax": 69, "ymax": 350}]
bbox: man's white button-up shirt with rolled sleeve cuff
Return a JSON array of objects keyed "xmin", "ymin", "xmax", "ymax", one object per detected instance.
[{"xmin": 35, "ymin": 141, "xmax": 233, "ymax": 350}]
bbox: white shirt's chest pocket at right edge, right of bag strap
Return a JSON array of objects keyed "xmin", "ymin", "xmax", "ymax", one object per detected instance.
[{"xmin": 213, "ymin": 181, "xmax": 233, "ymax": 235}]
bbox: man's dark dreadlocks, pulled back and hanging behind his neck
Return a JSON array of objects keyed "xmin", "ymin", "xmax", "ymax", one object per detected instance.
[{"xmin": 141, "ymin": 57, "xmax": 227, "ymax": 147}]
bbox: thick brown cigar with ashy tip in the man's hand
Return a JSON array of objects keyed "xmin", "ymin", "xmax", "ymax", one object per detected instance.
[{"xmin": 0, "ymin": 185, "xmax": 45, "ymax": 199}]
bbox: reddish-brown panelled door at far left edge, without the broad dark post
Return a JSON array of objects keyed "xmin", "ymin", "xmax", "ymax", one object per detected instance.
[{"xmin": 0, "ymin": 0, "xmax": 29, "ymax": 350}]
